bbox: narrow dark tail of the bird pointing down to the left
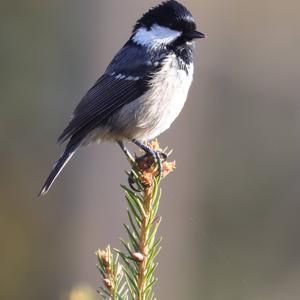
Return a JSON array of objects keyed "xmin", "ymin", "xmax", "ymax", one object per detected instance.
[{"xmin": 38, "ymin": 146, "xmax": 77, "ymax": 197}]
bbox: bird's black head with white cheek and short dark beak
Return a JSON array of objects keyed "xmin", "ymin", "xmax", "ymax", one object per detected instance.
[{"xmin": 131, "ymin": 0, "xmax": 205, "ymax": 48}]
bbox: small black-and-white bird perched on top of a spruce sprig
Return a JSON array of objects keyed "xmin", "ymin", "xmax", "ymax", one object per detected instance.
[{"xmin": 38, "ymin": 0, "xmax": 206, "ymax": 197}]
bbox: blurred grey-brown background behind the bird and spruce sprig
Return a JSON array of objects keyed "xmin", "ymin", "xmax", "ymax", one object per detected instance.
[{"xmin": 0, "ymin": 0, "xmax": 300, "ymax": 300}]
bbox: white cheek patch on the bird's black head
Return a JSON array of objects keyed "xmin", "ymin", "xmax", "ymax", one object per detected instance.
[{"xmin": 133, "ymin": 24, "xmax": 182, "ymax": 48}]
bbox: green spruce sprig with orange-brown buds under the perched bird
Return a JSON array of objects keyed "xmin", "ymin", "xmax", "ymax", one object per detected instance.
[{"xmin": 96, "ymin": 141, "xmax": 175, "ymax": 300}]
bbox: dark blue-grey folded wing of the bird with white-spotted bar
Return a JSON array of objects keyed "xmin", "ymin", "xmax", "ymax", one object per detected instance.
[{"xmin": 58, "ymin": 43, "xmax": 165, "ymax": 144}]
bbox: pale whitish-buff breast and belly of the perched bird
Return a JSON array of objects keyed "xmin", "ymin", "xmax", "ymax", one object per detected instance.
[{"xmin": 105, "ymin": 55, "xmax": 194, "ymax": 141}]
